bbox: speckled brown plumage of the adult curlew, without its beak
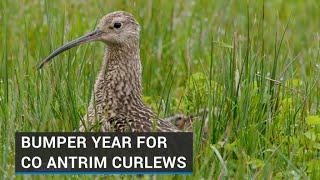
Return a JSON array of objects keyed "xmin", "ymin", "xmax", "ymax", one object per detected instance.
[{"xmin": 80, "ymin": 12, "xmax": 177, "ymax": 132}]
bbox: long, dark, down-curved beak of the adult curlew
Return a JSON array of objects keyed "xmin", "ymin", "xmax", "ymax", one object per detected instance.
[{"xmin": 37, "ymin": 30, "xmax": 103, "ymax": 69}]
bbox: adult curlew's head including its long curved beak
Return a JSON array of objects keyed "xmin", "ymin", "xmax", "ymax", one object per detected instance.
[{"xmin": 38, "ymin": 11, "xmax": 140, "ymax": 69}]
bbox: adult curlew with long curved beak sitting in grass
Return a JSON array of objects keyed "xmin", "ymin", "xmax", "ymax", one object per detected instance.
[{"xmin": 38, "ymin": 11, "xmax": 190, "ymax": 132}]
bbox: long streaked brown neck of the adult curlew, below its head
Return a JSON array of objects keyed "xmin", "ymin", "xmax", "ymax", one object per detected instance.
[{"xmin": 95, "ymin": 44, "xmax": 149, "ymax": 116}]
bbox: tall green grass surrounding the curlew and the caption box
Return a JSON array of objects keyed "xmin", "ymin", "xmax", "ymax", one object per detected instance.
[{"xmin": 0, "ymin": 0, "xmax": 320, "ymax": 179}]
